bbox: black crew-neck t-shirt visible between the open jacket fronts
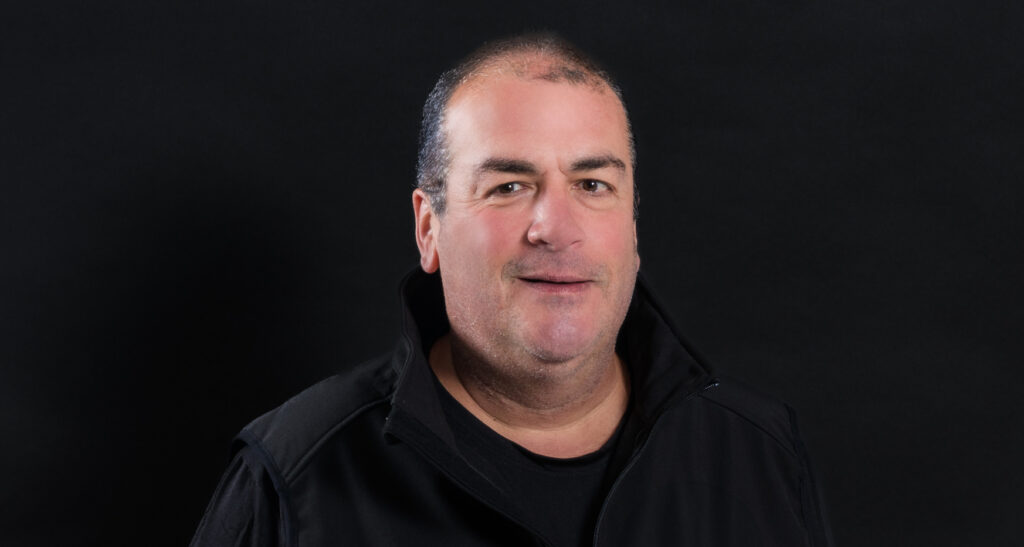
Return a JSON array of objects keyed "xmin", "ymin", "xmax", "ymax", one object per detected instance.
[{"xmin": 434, "ymin": 379, "xmax": 633, "ymax": 547}]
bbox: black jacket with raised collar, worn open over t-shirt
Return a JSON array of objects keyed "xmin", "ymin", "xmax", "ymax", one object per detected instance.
[{"xmin": 191, "ymin": 274, "xmax": 831, "ymax": 547}]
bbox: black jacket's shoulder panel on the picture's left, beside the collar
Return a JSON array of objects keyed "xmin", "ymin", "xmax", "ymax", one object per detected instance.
[{"xmin": 236, "ymin": 353, "xmax": 395, "ymax": 479}]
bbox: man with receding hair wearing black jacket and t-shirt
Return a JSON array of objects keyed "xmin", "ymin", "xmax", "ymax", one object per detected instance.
[{"xmin": 193, "ymin": 36, "xmax": 829, "ymax": 546}]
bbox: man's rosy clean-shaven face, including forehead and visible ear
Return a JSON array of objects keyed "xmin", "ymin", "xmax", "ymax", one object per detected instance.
[{"xmin": 414, "ymin": 74, "xmax": 640, "ymax": 374}]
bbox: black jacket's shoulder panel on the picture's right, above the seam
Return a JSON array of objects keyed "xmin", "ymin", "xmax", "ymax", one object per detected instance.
[{"xmin": 699, "ymin": 376, "xmax": 799, "ymax": 453}]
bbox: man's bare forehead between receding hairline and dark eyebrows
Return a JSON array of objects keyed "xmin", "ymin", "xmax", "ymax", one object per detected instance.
[{"xmin": 444, "ymin": 70, "xmax": 630, "ymax": 168}]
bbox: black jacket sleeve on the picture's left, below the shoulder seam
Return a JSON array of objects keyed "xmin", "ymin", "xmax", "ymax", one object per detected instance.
[{"xmin": 189, "ymin": 447, "xmax": 286, "ymax": 547}]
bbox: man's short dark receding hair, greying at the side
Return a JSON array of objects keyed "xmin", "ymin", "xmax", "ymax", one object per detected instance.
[{"xmin": 416, "ymin": 33, "xmax": 640, "ymax": 218}]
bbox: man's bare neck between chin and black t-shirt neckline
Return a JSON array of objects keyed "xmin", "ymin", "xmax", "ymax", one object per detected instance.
[{"xmin": 429, "ymin": 334, "xmax": 629, "ymax": 458}]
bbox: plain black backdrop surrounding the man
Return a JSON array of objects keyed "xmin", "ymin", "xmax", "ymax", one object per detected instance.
[{"xmin": 0, "ymin": 0, "xmax": 1024, "ymax": 546}]
